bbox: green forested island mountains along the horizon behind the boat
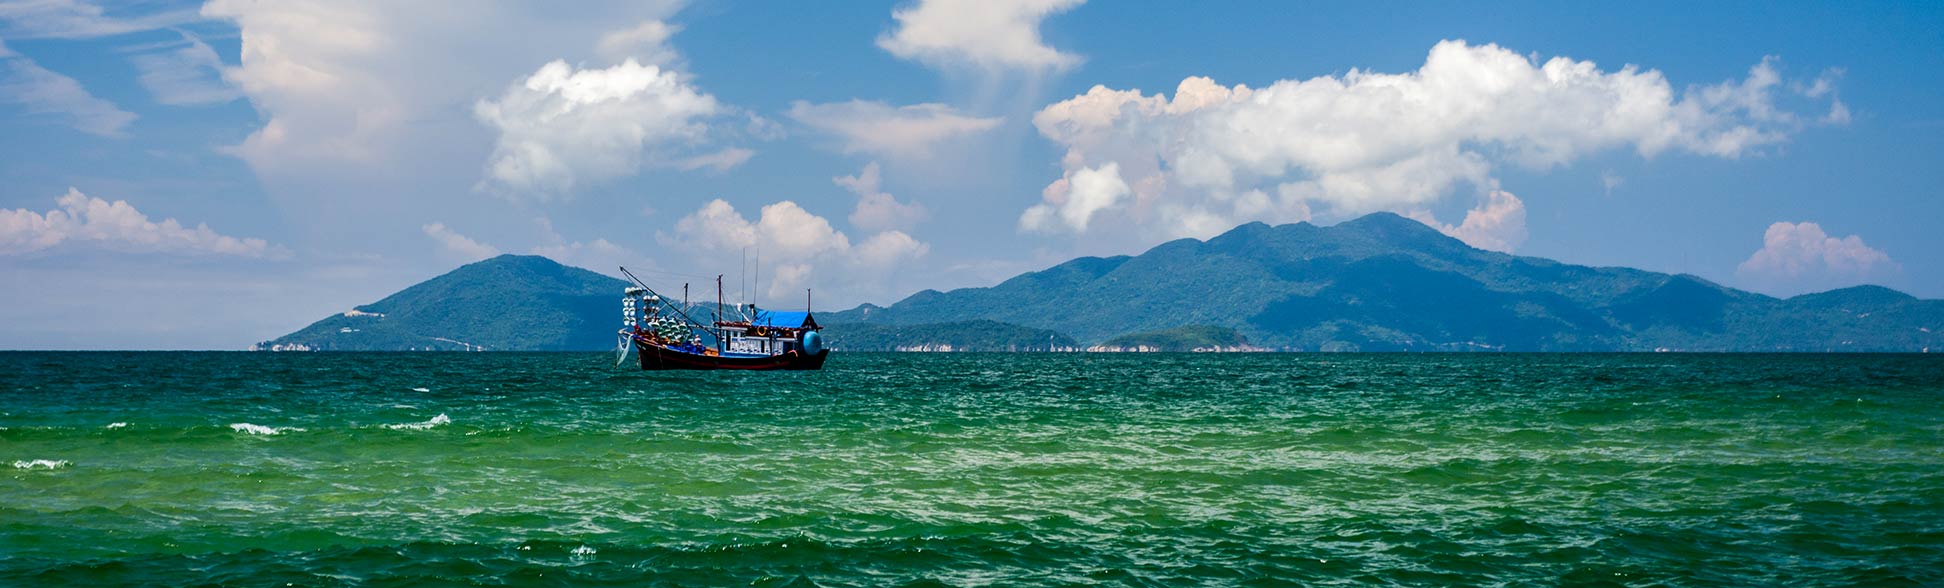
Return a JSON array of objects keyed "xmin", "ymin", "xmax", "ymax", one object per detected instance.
[{"xmin": 253, "ymin": 212, "xmax": 1944, "ymax": 352}]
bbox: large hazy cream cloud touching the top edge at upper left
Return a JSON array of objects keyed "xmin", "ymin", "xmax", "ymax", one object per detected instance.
[{"xmin": 202, "ymin": 0, "xmax": 677, "ymax": 172}]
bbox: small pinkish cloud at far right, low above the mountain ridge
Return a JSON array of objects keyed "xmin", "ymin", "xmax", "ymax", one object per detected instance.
[{"xmin": 1734, "ymin": 222, "xmax": 1901, "ymax": 294}]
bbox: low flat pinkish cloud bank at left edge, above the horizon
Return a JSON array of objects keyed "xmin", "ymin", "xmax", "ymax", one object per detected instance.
[{"xmin": 0, "ymin": 187, "xmax": 290, "ymax": 259}]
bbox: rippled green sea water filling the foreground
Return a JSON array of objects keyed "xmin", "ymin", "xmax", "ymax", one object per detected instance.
[{"xmin": 0, "ymin": 352, "xmax": 1944, "ymax": 586}]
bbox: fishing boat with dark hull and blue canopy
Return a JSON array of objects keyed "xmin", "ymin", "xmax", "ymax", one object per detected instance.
[{"xmin": 614, "ymin": 267, "xmax": 830, "ymax": 370}]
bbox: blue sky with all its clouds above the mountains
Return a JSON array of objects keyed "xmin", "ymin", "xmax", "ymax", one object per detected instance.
[{"xmin": 0, "ymin": 0, "xmax": 1944, "ymax": 349}]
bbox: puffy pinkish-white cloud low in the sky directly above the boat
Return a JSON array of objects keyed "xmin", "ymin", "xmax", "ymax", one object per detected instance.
[{"xmin": 657, "ymin": 199, "xmax": 931, "ymax": 300}]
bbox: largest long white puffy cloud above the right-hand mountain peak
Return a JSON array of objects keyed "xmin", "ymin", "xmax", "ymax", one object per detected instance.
[{"xmin": 1021, "ymin": 41, "xmax": 1842, "ymax": 245}]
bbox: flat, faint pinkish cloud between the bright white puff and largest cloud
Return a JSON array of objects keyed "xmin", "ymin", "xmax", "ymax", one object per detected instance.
[{"xmin": 789, "ymin": 99, "xmax": 1001, "ymax": 158}]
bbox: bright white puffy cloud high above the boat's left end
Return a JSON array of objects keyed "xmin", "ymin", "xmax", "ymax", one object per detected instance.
[{"xmin": 474, "ymin": 58, "xmax": 730, "ymax": 199}]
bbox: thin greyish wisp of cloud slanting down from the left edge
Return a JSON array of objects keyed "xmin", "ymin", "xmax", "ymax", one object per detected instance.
[{"xmin": 0, "ymin": 45, "xmax": 136, "ymax": 136}]
